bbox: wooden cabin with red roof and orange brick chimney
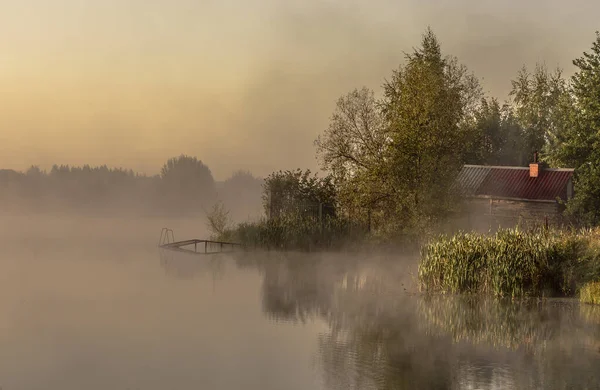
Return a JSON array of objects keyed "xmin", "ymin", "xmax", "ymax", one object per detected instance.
[{"xmin": 458, "ymin": 158, "xmax": 573, "ymax": 230}]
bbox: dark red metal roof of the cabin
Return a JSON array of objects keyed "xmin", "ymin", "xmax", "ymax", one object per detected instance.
[{"xmin": 458, "ymin": 165, "xmax": 573, "ymax": 200}]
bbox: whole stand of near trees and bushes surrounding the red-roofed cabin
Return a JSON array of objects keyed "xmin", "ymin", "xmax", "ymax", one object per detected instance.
[{"xmin": 264, "ymin": 29, "xmax": 600, "ymax": 244}]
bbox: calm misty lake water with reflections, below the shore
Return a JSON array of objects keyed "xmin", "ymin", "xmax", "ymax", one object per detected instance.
[{"xmin": 0, "ymin": 217, "xmax": 600, "ymax": 390}]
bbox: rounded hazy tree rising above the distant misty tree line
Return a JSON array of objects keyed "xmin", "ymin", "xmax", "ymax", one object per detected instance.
[{"xmin": 160, "ymin": 155, "xmax": 215, "ymax": 207}]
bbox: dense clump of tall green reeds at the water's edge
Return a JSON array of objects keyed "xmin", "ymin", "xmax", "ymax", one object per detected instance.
[{"xmin": 419, "ymin": 229, "xmax": 600, "ymax": 297}]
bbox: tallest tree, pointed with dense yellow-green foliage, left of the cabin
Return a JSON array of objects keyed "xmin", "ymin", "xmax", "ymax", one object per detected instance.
[{"xmin": 383, "ymin": 29, "xmax": 482, "ymax": 235}]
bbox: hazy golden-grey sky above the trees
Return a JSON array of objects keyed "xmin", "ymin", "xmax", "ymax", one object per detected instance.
[{"xmin": 0, "ymin": 0, "xmax": 600, "ymax": 180}]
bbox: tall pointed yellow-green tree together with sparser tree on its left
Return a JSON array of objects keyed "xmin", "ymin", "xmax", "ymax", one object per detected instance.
[{"xmin": 315, "ymin": 30, "xmax": 482, "ymax": 236}]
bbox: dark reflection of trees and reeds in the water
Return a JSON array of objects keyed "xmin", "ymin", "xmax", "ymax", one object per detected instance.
[{"xmin": 238, "ymin": 255, "xmax": 600, "ymax": 389}]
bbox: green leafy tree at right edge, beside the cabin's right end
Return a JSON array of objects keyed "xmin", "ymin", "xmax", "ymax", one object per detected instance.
[{"xmin": 555, "ymin": 32, "xmax": 600, "ymax": 225}]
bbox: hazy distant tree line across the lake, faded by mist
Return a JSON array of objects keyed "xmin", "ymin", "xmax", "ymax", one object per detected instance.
[{"xmin": 0, "ymin": 155, "xmax": 263, "ymax": 219}]
